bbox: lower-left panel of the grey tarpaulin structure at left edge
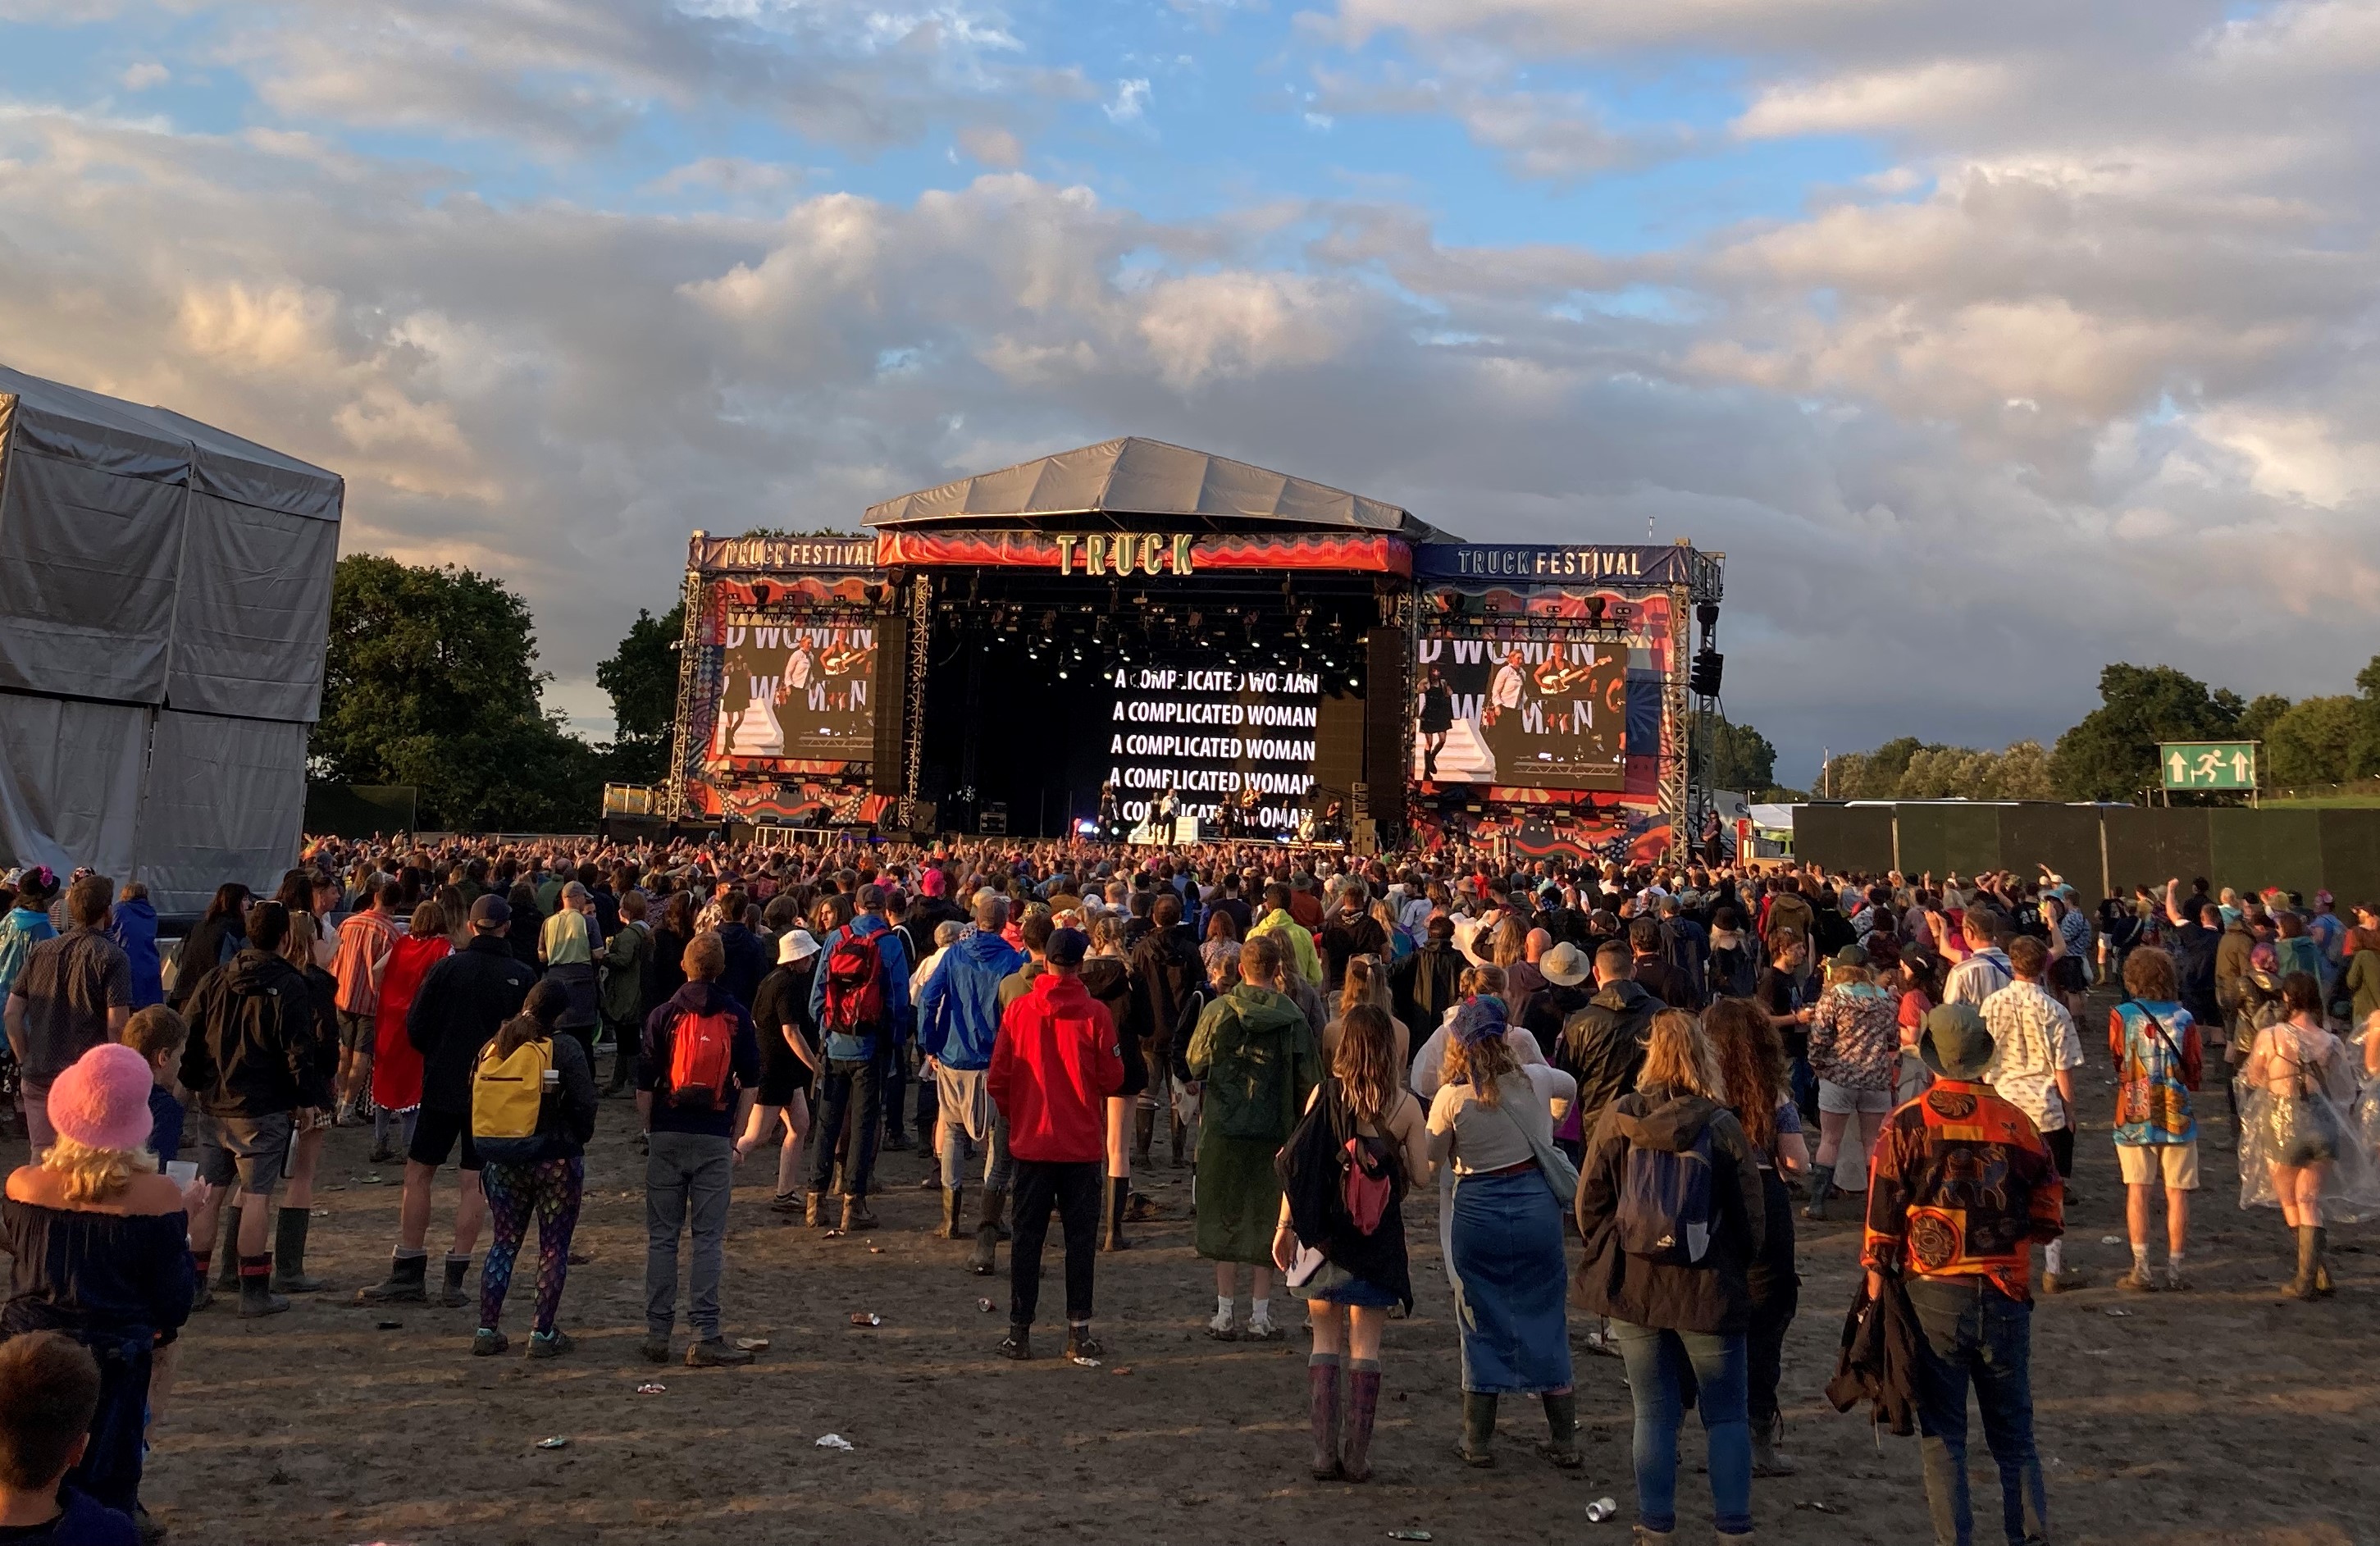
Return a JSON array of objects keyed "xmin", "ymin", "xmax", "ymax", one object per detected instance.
[{"xmin": 0, "ymin": 692, "xmax": 153, "ymax": 878}]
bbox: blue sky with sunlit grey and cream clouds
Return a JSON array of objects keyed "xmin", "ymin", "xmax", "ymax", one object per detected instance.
[{"xmin": 0, "ymin": 0, "xmax": 2380, "ymax": 782}]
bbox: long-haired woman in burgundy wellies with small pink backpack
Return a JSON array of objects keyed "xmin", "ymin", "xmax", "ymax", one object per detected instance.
[{"xmin": 1274, "ymin": 999, "xmax": 1430, "ymax": 1482}]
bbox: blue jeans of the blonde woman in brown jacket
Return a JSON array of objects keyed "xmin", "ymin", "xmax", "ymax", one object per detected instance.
[{"xmin": 1612, "ymin": 1320, "xmax": 1752, "ymax": 1535}]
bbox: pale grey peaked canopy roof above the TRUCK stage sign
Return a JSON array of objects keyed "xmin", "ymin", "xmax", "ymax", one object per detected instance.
[{"xmin": 866, "ymin": 436, "xmax": 1445, "ymax": 542}]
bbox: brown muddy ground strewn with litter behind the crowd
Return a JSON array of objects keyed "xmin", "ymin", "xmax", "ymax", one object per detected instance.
[{"xmin": 145, "ymin": 1013, "xmax": 2380, "ymax": 1546}]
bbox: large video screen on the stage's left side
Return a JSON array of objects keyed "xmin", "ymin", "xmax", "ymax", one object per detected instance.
[{"xmin": 709, "ymin": 611, "xmax": 876, "ymax": 764}]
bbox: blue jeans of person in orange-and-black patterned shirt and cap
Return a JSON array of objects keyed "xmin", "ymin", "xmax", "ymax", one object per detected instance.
[{"xmin": 1908, "ymin": 1277, "xmax": 2049, "ymax": 1546}]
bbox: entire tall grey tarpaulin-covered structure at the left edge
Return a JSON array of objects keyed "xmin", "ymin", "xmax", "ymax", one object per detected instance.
[{"xmin": 0, "ymin": 369, "xmax": 345, "ymax": 911}]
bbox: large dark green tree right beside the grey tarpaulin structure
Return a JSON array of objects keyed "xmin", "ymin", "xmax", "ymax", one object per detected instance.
[{"xmin": 307, "ymin": 554, "xmax": 602, "ymax": 832}]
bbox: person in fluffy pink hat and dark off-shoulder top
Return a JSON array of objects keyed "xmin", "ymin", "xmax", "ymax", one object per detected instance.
[{"xmin": 0, "ymin": 1042, "xmax": 195, "ymax": 1517}]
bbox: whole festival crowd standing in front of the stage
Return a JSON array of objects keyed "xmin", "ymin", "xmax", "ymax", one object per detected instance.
[{"xmin": 0, "ymin": 840, "xmax": 2380, "ymax": 1544}]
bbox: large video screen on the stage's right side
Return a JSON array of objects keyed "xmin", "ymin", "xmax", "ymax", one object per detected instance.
[{"xmin": 1414, "ymin": 626, "xmax": 1628, "ymax": 790}]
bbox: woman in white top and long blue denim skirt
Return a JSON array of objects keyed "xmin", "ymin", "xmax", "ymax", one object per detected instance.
[{"xmin": 1430, "ymin": 994, "xmax": 1580, "ymax": 1470}]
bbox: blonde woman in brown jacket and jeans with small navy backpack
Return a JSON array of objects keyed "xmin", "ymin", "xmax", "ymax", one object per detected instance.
[{"xmin": 1578, "ymin": 1009, "xmax": 1768, "ymax": 1541}]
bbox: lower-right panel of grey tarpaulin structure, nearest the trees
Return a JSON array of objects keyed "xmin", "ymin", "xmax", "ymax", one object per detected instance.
[{"xmin": 138, "ymin": 709, "xmax": 307, "ymax": 914}]
